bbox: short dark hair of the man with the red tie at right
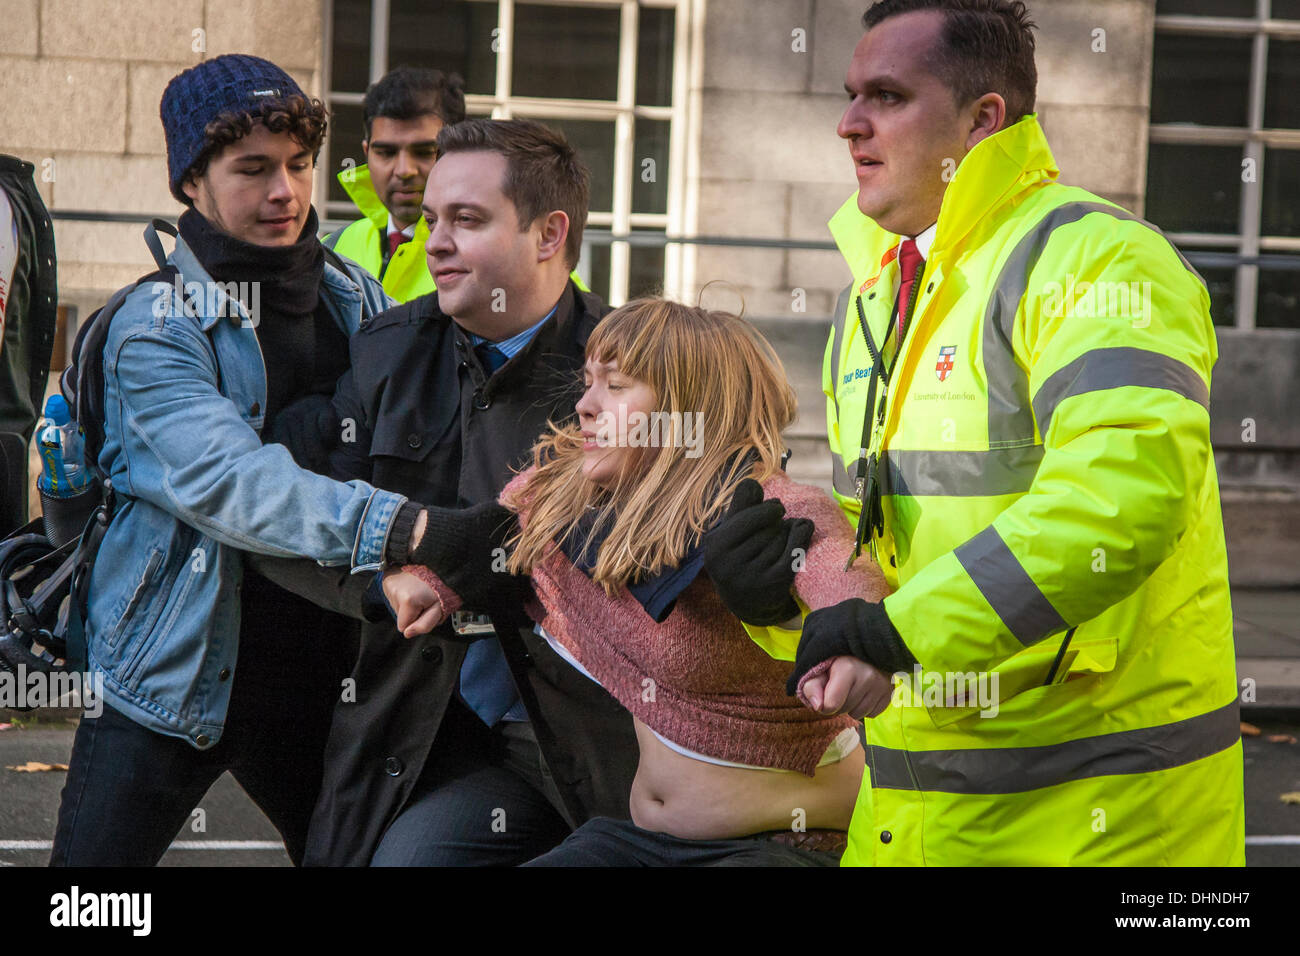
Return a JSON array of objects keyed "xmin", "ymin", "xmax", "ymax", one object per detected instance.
[{"xmin": 862, "ymin": 0, "xmax": 1039, "ymax": 126}]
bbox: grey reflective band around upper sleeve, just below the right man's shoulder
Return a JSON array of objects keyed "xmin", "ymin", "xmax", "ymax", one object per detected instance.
[{"xmin": 1034, "ymin": 347, "xmax": 1210, "ymax": 434}]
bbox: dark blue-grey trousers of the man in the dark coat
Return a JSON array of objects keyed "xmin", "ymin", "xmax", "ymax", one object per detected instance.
[{"xmin": 371, "ymin": 698, "xmax": 571, "ymax": 866}]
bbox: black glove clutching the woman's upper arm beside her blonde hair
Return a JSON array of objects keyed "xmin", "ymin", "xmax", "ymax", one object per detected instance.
[{"xmin": 703, "ymin": 479, "xmax": 813, "ymax": 627}]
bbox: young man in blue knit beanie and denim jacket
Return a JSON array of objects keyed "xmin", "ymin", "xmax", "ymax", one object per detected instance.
[{"xmin": 51, "ymin": 56, "xmax": 406, "ymax": 866}]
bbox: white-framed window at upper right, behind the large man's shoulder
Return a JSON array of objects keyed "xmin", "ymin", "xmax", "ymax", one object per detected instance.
[{"xmin": 1147, "ymin": 0, "xmax": 1300, "ymax": 329}]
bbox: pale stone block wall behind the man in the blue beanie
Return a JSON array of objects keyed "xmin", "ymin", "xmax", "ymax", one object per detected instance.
[{"xmin": 0, "ymin": 0, "xmax": 322, "ymax": 343}]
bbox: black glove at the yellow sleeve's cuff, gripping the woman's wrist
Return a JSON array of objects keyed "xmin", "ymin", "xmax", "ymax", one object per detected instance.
[{"xmin": 785, "ymin": 597, "xmax": 917, "ymax": 697}]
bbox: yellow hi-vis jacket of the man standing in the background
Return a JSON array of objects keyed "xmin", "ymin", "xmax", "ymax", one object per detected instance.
[{"xmin": 325, "ymin": 165, "xmax": 434, "ymax": 302}]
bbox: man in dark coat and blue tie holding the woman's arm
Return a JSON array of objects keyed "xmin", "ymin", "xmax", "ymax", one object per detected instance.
[{"xmin": 259, "ymin": 120, "xmax": 637, "ymax": 865}]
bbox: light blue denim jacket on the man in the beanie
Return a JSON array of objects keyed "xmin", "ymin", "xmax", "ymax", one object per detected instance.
[{"xmin": 86, "ymin": 228, "xmax": 406, "ymax": 749}]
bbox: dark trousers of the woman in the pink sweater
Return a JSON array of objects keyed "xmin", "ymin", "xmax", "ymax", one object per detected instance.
[{"xmin": 524, "ymin": 817, "xmax": 840, "ymax": 866}]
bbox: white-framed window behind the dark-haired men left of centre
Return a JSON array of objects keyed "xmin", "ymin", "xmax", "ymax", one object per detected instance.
[{"xmin": 325, "ymin": 0, "xmax": 692, "ymax": 304}]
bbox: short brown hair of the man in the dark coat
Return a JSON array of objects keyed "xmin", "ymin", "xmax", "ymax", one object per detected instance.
[{"xmin": 438, "ymin": 118, "xmax": 592, "ymax": 269}]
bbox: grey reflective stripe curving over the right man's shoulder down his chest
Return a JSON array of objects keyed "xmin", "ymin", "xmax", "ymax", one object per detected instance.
[{"xmin": 983, "ymin": 203, "xmax": 1204, "ymax": 447}]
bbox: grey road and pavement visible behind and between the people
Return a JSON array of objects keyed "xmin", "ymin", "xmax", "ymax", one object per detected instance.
[{"xmin": 0, "ymin": 591, "xmax": 1300, "ymax": 868}]
